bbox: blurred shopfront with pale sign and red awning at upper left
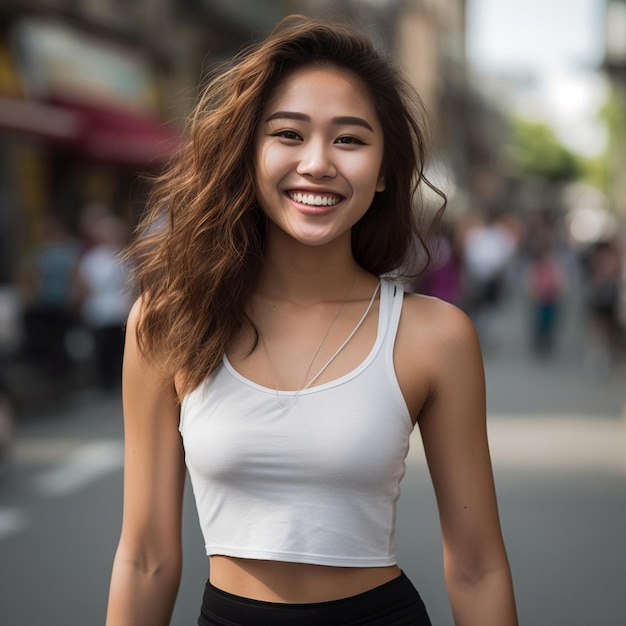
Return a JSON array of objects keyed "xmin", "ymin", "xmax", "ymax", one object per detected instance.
[{"xmin": 0, "ymin": 0, "xmax": 177, "ymax": 282}]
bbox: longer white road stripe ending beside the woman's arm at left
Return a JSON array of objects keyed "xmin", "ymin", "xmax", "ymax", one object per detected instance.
[{"xmin": 33, "ymin": 441, "xmax": 124, "ymax": 497}]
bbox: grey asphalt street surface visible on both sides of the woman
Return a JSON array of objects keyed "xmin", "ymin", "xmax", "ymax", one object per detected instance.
[{"xmin": 0, "ymin": 290, "xmax": 626, "ymax": 626}]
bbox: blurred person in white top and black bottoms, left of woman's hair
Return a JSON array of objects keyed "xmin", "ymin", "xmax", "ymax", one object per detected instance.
[{"xmin": 74, "ymin": 213, "xmax": 132, "ymax": 391}]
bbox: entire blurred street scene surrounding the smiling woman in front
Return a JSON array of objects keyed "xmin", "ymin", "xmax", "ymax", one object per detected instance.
[{"xmin": 0, "ymin": 0, "xmax": 626, "ymax": 626}]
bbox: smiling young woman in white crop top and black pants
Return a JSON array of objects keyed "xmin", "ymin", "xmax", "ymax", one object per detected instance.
[{"xmin": 107, "ymin": 17, "xmax": 516, "ymax": 626}]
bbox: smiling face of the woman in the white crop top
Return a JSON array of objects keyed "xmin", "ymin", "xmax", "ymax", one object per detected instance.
[{"xmin": 254, "ymin": 66, "xmax": 385, "ymax": 246}]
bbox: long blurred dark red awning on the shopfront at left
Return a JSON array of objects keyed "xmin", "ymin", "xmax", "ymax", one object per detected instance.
[{"xmin": 0, "ymin": 98, "xmax": 180, "ymax": 167}]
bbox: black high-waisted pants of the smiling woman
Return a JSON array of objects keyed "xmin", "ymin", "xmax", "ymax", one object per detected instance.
[{"xmin": 198, "ymin": 573, "xmax": 431, "ymax": 626}]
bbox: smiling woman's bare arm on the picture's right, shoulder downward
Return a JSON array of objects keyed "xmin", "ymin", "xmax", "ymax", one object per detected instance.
[{"xmin": 410, "ymin": 301, "xmax": 518, "ymax": 626}]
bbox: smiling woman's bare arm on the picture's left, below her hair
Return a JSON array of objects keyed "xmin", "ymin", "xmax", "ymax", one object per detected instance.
[{"xmin": 106, "ymin": 304, "xmax": 185, "ymax": 626}]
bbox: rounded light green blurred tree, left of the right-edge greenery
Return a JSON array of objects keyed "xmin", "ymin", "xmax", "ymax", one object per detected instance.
[{"xmin": 509, "ymin": 118, "xmax": 583, "ymax": 183}]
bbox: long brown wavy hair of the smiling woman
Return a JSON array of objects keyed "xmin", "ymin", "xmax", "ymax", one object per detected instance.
[{"xmin": 128, "ymin": 16, "xmax": 445, "ymax": 393}]
